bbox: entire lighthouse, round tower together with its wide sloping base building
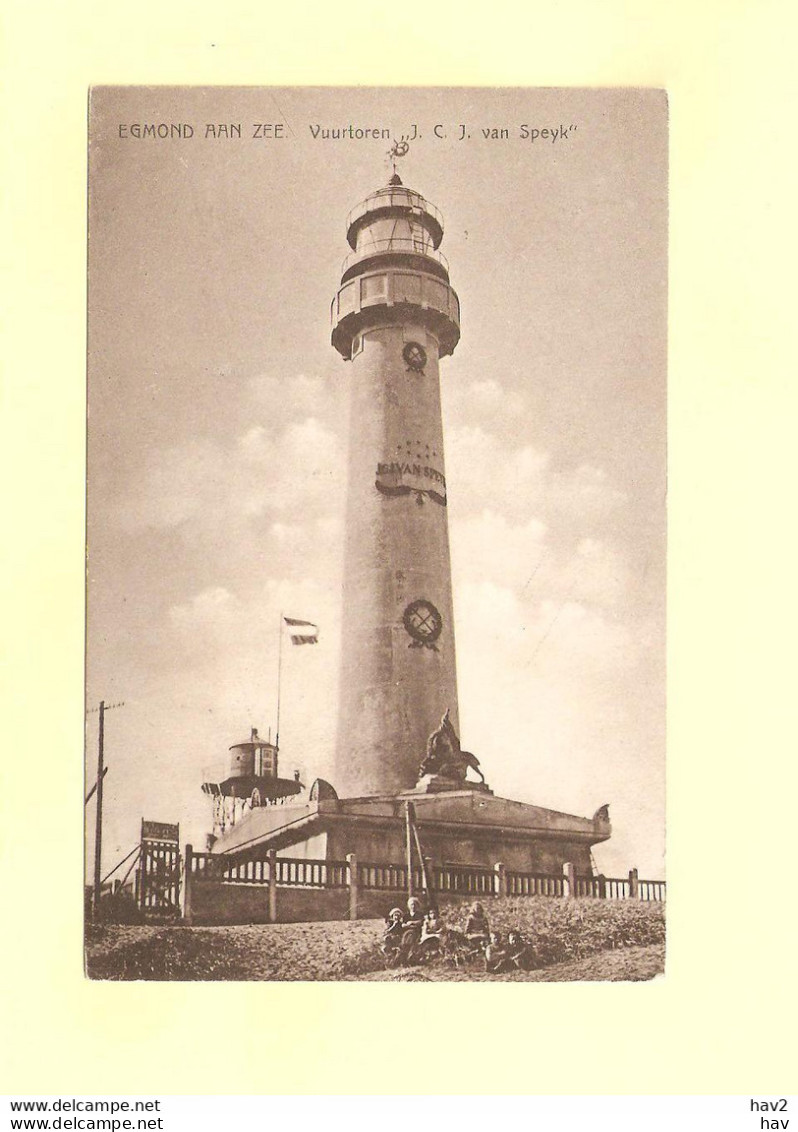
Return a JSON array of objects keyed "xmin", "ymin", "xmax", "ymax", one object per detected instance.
[{"xmin": 206, "ymin": 165, "xmax": 611, "ymax": 892}]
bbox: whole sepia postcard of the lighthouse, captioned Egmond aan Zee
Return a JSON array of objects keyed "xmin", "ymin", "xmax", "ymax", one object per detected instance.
[{"xmin": 83, "ymin": 86, "xmax": 668, "ymax": 983}]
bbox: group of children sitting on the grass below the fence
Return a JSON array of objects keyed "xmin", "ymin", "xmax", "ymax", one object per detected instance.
[{"xmin": 381, "ymin": 897, "xmax": 534, "ymax": 975}]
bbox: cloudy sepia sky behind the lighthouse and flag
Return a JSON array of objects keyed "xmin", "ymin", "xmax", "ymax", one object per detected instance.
[{"xmin": 86, "ymin": 87, "xmax": 668, "ymax": 877}]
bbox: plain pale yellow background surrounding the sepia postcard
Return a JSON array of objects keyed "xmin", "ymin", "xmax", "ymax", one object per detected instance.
[{"xmin": 0, "ymin": 0, "xmax": 798, "ymax": 1095}]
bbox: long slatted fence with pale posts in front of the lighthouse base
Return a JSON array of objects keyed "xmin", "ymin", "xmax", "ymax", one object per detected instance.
[{"xmin": 182, "ymin": 846, "xmax": 666, "ymax": 923}]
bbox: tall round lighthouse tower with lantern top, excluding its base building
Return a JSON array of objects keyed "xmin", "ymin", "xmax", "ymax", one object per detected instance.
[{"xmin": 332, "ymin": 173, "xmax": 460, "ymax": 797}]
